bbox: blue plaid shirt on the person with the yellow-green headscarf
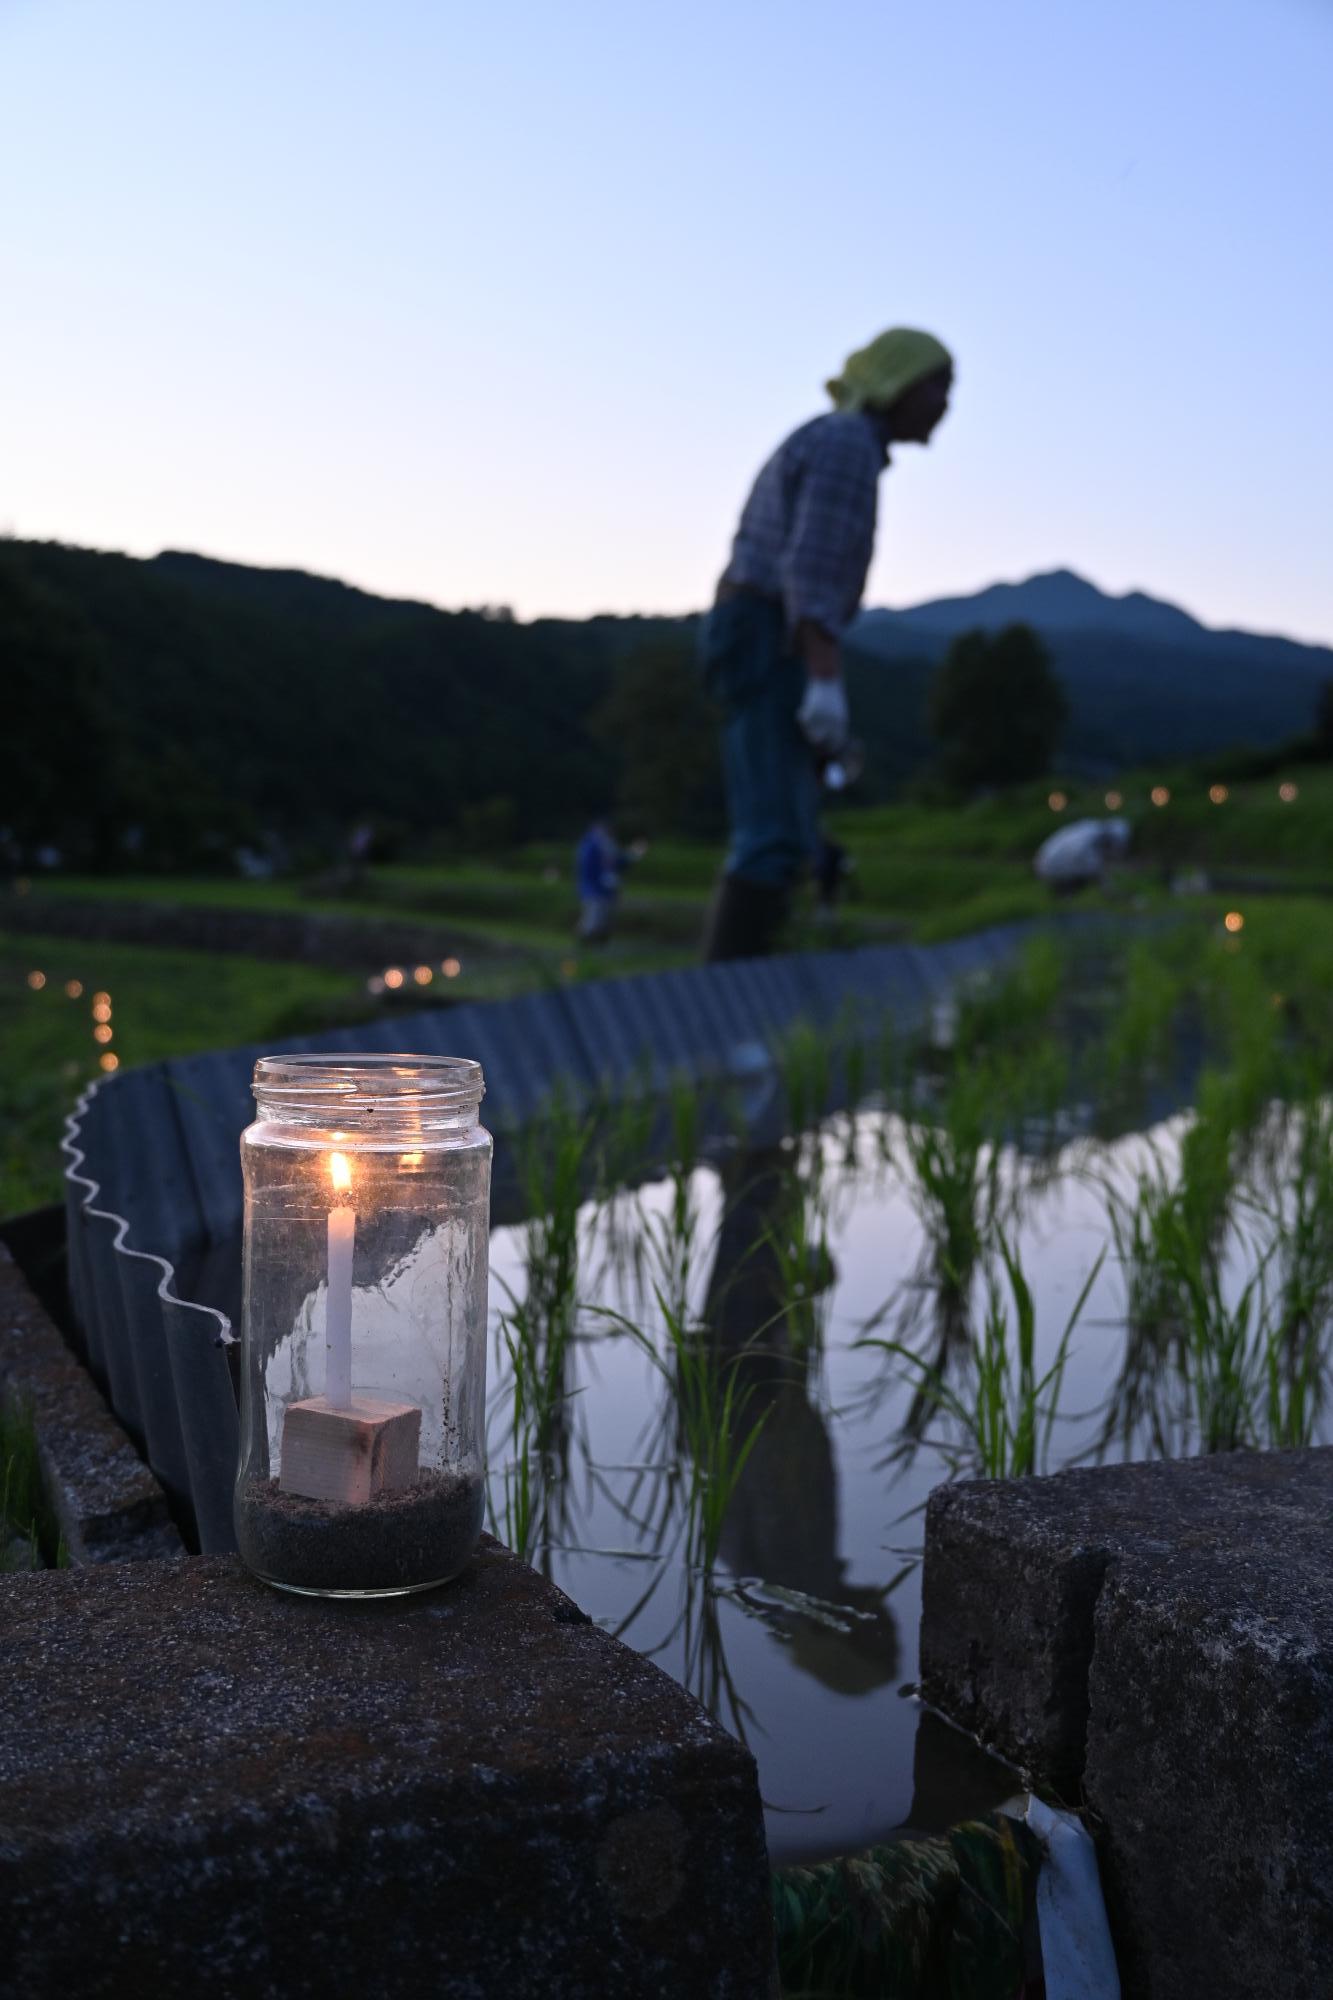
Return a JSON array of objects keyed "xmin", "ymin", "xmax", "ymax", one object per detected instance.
[{"xmin": 723, "ymin": 410, "xmax": 889, "ymax": 636}]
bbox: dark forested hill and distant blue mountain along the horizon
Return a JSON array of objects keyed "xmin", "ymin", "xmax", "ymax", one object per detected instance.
[{"xmin": 0, "ymin": 540, "xmax": 1333, "ymax": 866}]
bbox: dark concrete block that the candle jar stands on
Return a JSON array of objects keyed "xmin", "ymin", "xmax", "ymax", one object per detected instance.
[{"xmin": 0, "ymin": 1542, "xmax": 773, "ymax": 2000}]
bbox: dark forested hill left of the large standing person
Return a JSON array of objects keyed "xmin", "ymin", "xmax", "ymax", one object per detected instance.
[{"xmin": 0, "ymin": 542, "xmax": 685, "ymax": 860}]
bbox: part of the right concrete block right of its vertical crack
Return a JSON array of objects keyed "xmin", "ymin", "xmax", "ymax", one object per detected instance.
[{"xmin": 1083, "ymin": 1484, "xmax": 1333, "ymax": 2000}]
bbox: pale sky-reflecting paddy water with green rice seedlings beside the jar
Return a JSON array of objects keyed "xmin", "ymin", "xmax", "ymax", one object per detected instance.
[{"xmin": 490, "ymin": 1084, "xmax": 1333, "ymax": 1862}]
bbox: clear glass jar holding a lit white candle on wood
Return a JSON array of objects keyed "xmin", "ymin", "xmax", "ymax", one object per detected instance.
[{"xmin": 236, "ymin": 1056, "xmax": 490, "ymax": 1598}]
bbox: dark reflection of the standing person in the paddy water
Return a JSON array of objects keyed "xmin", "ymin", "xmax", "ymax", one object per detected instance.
[{"xmin": 705, "ymin": 1148, "xmax": 899, "ymax": 1694}]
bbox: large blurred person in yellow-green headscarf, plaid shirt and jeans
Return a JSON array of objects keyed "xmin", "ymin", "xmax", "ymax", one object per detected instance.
[{"xmin": 701, "ymin": 326, "xmax": 953, "ymax": 960}]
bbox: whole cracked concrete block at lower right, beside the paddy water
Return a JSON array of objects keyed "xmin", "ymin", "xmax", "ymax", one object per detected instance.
[{"xmin": 921, "ymin": 1448, "xmax": 1333, "ymax": 2000}]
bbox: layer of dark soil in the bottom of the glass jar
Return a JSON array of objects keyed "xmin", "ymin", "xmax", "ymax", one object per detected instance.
[{"xmin": 236, "ymin": 1470, "xmax": 484, "ymax": 1592}]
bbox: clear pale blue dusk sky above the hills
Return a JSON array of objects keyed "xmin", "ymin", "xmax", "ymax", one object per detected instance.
[{"xmin": 0, "ymin": 0, "xmax": 1333, "ymax": 640}]
